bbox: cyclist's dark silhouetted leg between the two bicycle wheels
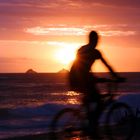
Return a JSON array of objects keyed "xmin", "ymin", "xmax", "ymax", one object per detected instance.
[{"xmin": 85, "ymin": 77, "xmax": 102, "ymax": 139}]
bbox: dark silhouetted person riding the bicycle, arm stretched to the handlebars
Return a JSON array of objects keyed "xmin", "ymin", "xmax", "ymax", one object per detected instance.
[{"xmin": 69, "ymin": 31, "xmax": 121, "ymax": 139}]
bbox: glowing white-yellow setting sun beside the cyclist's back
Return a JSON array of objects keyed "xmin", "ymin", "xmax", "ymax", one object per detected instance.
[{"xmin": 55, "ymin": 47, "xmax": 76, "ymax": 65}]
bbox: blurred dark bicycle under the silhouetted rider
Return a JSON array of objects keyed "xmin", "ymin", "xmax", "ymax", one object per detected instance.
[{"xmin": 50, "ymin": 82, "xmax": 135, "ymax": 140}]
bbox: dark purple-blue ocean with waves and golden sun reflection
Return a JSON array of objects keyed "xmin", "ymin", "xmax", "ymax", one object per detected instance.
[{"xmin": 0, "ymin": 72, "xmax": 140, "ymax": 139}]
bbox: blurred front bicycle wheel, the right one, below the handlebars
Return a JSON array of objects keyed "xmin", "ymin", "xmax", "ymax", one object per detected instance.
[{"xmin": 106, "ymin": 103, "xmax": 135, "ymax": 140}]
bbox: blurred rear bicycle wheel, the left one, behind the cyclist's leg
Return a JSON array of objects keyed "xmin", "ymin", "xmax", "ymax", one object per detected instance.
[{"xmin": 51, "ymin": 108, "xmax": 86, "ymax": 140}]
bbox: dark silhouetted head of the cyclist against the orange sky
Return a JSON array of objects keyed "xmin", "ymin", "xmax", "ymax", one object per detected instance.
[{"xmin": 89, "ymin": 31, "xmax": 99, "ymax": 47}]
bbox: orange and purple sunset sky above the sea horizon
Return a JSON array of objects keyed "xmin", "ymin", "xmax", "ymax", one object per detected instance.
[{"xmin": 0, "ymin": 0, "xmax": 140, "ymax": 73}]
